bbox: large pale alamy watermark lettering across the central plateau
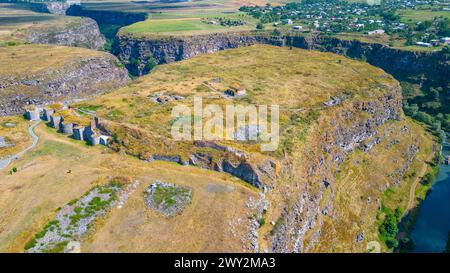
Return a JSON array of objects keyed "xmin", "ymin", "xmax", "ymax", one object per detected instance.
[{"xmin": 171, "ymin": 96, "xmax": 280, "ymax": 152}]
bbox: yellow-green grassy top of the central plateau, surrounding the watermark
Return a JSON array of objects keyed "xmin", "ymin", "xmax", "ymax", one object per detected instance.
[{"xmin": 74, "ymin": 45, "xmax": 395, "ymax": 157}]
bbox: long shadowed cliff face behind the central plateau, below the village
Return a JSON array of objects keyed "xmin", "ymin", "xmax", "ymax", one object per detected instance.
[{"xmin": 113, "ymin": 32, "xmax": 450, "ymax": 80}]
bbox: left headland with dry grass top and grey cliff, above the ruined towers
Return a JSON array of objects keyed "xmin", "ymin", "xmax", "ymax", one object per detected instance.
[{"xmin": 0, "ymin": 45, "xmax": 129, "ymax": 116}]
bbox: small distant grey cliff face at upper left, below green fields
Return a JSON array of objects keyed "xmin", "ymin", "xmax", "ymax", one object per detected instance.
[{"xmin": 26, "ymin": 18, "xmax": 106, "ymax": 49}]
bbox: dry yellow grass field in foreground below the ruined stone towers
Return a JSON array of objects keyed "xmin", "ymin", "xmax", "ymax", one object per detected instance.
[{"xmin": 0, "ymin": 120, "xmax": 257, "ymax": 252}]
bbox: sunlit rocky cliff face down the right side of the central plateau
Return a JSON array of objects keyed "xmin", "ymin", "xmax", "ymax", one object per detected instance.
[{"xmin": 270, "ymin": 85, "xmax": 403, "ymax": 252}]
